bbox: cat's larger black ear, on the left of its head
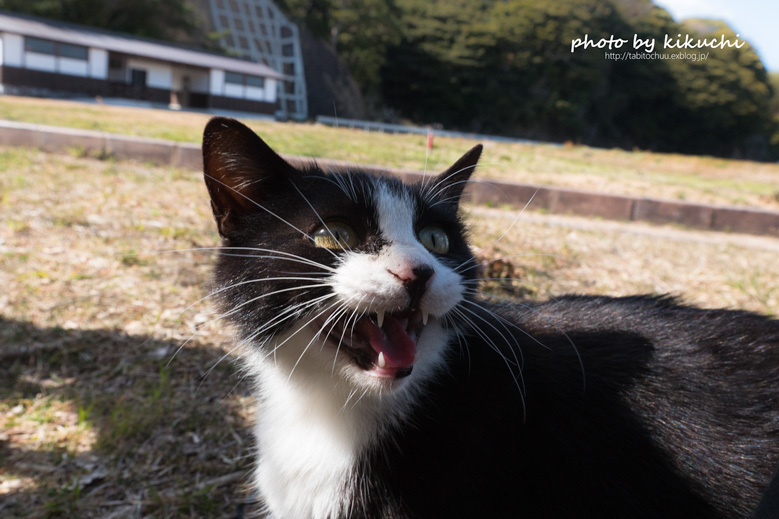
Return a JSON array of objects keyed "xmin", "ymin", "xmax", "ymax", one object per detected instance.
[{"xmin": 203, "ymin": 117, "xmax": 296, "ymax": 237}]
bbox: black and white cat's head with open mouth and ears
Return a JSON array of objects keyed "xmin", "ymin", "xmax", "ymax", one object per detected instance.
[{"xmin": 203, "ymin": 118, "xmax": 481, "ymax": 391}]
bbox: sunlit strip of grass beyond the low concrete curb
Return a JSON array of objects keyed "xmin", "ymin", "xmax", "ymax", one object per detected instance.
[{"xmin": 0, "ymin": 96, "xmax": 779, "ymax": 210}]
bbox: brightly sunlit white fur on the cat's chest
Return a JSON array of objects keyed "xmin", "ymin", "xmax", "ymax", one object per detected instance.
[{"xmin": 256, "ymin": 362, "xmax": 372, "ymax": 519}]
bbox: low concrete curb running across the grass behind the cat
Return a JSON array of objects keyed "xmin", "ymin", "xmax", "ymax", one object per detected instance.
[{"xmin": 0, "ymin": 121, "xmax": 779, "ymax": 237}]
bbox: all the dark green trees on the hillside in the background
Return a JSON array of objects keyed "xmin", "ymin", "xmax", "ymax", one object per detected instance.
[{"xmin": 0, "ymin": 0, "xmax": 779, "ymax": 160}]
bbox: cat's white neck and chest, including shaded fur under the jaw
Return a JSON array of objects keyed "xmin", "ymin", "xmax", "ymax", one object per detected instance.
[{"xmin": 249, "ymin": 333, "xmax": 430, "ymax": 519}]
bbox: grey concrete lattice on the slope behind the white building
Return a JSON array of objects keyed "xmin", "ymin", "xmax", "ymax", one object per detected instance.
[{"xmin": 194, "ymin": 0, "xmax": 308, "ymax": 119}]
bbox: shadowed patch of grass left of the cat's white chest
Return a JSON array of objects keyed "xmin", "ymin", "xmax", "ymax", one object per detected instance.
[{"xmin": 0, "ymin": 316, "xmax": 262, "ymax": 518}]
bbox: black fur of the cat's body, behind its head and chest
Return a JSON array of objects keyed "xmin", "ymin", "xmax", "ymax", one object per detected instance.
[{"xmin": 356, "ymin": 297, "xmax": 779, "ymax": 518}]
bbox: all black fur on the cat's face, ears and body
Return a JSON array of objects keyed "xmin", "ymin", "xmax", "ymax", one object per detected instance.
[{"xmin": 204, "ymin": 119, "xmax": 779, "ymax": 519}]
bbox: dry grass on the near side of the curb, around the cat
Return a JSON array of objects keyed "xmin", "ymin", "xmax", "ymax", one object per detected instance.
[{"xmin": 0, "ymin": 141, "xmax": 779, "ymax": 518}]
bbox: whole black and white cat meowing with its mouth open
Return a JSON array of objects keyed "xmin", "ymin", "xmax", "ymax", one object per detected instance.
[{"xmin": 203, "ymin": 118, "xmax": 779, "ymax": 519}]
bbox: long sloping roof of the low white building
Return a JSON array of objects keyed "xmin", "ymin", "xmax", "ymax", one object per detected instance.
[{"xmin": 0, "ymin": 11, "xmax": 285, "ymax": 79}]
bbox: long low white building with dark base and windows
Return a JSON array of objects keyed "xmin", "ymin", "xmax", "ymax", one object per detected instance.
[{"xmin": 0, "ymin": 11, "xmax": 285, "ymax": 115}]
